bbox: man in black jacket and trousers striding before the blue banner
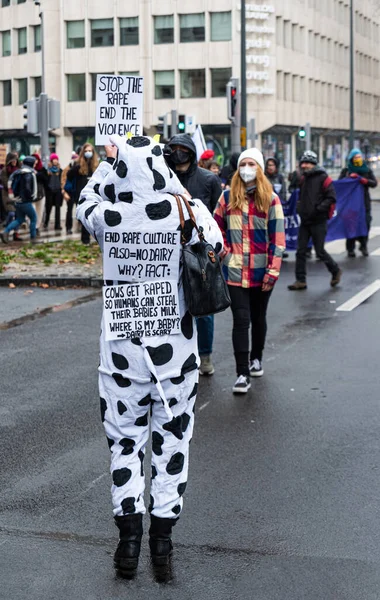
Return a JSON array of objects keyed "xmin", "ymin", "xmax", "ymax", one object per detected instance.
[{"xmin": 288, "ymin": 150, "xmax": 342, "ymax": 290}]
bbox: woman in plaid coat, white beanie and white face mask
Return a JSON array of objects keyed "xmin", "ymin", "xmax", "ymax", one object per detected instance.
[{"xmin": 214, "ymin": 148, "xmax": 285, "ymax": 394}]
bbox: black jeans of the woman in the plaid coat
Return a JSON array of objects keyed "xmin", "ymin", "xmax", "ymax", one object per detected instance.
[{"xmin": 228, "ymin": 285, "xmax": 272, "ymax": 375}]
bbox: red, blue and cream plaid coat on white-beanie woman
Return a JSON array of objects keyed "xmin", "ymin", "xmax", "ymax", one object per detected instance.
[{"xmin": 214, "ymin": 191, "xmax": 285, "ymax": 288}]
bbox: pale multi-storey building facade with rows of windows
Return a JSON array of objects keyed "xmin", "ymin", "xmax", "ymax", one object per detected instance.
[{"xmin": 0, "ymin": 0, "xmax": 380, "ymax": 170}]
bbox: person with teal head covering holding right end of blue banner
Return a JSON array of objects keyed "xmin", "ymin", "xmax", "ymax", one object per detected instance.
[{"xmin": 339, "ymin": 148, "xmax": 377, "ymax": 258}]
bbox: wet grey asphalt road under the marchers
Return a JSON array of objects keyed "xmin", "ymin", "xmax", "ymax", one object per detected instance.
[{"xmin": 0, "ymin": 209, "xmax": 380, "ymax": 600}]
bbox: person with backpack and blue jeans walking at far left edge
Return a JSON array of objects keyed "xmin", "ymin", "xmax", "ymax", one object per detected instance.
[{"xmin": 0, "ymin": 156, "xmax": 37, "ymax": 244}]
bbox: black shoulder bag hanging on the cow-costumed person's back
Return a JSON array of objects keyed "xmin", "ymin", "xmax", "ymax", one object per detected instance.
[{"xmin": 175, "ymin": 195, "xmax": 231, "ymax": 317}]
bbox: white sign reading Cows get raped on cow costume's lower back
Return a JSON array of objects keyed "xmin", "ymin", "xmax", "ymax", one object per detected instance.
[{"xmin": 103, "ymin": 280, "xmax": 181, "ymax": 341}]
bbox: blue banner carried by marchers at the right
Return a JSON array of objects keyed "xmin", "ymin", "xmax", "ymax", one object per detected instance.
[{"xmin": 283, "ymin": 178, "xmax": 368, "ymax": 250}]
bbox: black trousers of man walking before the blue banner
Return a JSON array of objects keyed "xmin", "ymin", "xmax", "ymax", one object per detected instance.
[{"xmin": 296, "ymin": 223, "xmax": 339, "ymax": 283}]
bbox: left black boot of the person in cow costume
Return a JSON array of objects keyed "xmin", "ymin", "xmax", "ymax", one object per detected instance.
[{"xmin": 113, "ymin": 514, "xmax": 143, "ymax": 579}]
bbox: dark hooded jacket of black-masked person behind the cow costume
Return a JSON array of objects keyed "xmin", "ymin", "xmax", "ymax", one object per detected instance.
[{"xmin": 165, "ymin": 133, "xmax": 222, "ymax": 212}]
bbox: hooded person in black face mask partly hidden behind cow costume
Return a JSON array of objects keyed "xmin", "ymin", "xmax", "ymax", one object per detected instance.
[{"xmin": 164, "ymin": 133, "xmax": 222, "ymax": 375}]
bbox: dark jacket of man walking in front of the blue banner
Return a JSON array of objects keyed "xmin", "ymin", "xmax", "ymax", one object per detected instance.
[{"xmin": 297, "ymin": 165, "xmax": 336, "ymax": 225}]
